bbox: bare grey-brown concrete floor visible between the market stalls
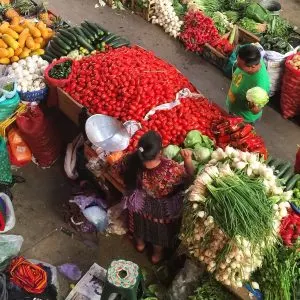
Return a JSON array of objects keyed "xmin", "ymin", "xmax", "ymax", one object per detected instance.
[{"xmin": 8, "ymin": 0, "xmax": 300, "ymax": 299}]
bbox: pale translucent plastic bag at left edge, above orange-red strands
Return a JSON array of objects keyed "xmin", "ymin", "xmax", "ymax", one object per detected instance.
[{"xmin": 0, "ymin": 234, "xmax": 24, "ymax": 271}]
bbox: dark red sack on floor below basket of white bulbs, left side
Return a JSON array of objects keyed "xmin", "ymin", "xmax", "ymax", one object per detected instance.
[{"xmin": 16, "ymin": 106, "xmax": 61, "ymax": 167}]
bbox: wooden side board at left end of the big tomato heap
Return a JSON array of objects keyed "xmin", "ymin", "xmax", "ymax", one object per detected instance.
[{"xmin": 57, "ymin": 88, "xmax": 83, "ymax": 125}]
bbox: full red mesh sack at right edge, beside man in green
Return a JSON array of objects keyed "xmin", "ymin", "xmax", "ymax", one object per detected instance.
[{"xmin": 280, "ymin": 54, "xmax": 300, "ymax": 118}]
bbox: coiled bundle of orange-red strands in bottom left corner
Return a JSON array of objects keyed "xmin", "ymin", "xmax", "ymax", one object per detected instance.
[{"xmin": 8, "ymin": 256, "xmax": 47, "ymax": 294}]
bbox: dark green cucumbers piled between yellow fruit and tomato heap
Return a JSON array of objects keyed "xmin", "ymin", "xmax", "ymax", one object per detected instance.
[{"xmin": 43, "ymin": 21, "xmax": 129, "ymax": 62}]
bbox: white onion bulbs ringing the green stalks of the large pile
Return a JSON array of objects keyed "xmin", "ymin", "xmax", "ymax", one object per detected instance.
[{"xmin": 181, "ymin": 146, "xmax": 292, "ymax": 287}]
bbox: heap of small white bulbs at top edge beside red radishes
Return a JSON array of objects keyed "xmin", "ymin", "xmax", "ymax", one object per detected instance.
[{"xmin": 150, "ymin": 0, "xmax": 183, "ymax": 38}]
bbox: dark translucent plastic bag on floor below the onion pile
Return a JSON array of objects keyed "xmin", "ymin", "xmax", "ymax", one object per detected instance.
[{"xmin": 168, "ymin": 259, "xmax": 205, "ymax": 300}]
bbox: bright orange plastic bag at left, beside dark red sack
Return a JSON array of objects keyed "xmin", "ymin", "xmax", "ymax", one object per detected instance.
[{"xmin": 8, "ymin": 128, "xmax": 32, "ymax": 166}]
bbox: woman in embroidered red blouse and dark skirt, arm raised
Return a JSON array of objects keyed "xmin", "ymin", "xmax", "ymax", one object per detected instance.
[{"xmin": 121, "ymin": 131, "xmax": 194, "ymax": 264}]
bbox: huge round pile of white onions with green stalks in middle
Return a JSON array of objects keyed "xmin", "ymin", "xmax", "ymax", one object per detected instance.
[{"xmin": 180, "ymin": 146, "xmax": 292, "ymax": 287}]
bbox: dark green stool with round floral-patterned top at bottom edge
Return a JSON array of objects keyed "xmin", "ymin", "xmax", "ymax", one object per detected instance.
[{"xmin": 101, "ymin": 259, "xmax": 144, "ymax": 300}]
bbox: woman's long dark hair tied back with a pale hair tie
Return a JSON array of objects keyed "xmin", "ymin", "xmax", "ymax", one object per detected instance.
[{"xmin": 123, "ymin": 131, "xmax": 162, "ymax": 190}]
